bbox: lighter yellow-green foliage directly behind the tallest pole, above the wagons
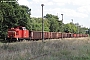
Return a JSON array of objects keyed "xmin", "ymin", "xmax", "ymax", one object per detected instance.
[{"xmin": 31, "ymin": 18, "xmax": 49, "ymax": 31}]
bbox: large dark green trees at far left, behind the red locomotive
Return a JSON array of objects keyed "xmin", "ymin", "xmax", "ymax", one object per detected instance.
[{"xmin": 0, "ymin": 0, "xmax": 31, "ymax": 36}]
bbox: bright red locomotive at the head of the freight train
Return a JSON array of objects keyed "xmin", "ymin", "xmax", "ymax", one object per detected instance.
[{"xmin": 7, "ymin": 26, "xmax": 29, "ymax": 40}]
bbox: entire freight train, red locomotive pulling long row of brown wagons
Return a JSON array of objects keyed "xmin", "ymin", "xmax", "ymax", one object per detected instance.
[{"xmin": 7, "ymin": 26, "xmax": 88, "ymax": 40}]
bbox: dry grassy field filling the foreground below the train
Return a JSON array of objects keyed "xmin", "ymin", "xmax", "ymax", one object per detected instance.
[{"xmin": 0, "ymin": 38, "xmax": 90, "ymax": 60}]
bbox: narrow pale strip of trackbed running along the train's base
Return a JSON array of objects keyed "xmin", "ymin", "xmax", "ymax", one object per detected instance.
[{"xmin": 0, "ymin": 37, "xmax": 90, "ymax": 44}]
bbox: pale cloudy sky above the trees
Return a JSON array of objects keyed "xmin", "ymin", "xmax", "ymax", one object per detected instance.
[{"xmin": 18, "ymin": 0, "xmax": 90, "ymax": 28}]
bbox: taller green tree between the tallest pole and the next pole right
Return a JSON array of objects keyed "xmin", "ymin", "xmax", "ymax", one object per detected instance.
[{"xmin": 44, "ymin": 14, "xmax": 59, "ymax": 32}]
